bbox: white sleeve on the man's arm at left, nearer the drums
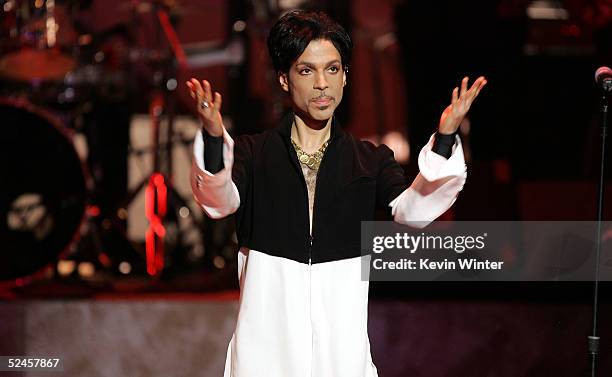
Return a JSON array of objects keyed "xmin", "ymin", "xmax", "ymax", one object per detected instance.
[{"xmin": 191, "ymin": 128, "xmax": 240, "ymax": 219}]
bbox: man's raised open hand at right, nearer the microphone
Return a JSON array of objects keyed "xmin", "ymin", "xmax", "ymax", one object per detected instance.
[{"xmin": 438, "ymin": 76, "xmax": 487, "ymax": 134}]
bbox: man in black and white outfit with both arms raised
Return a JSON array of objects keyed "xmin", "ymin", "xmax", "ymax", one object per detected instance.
[{"xmin": 187, "ymin": 11, "xmax": 486, "ymax": 377}]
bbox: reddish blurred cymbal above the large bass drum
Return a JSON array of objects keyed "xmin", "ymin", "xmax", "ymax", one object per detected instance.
[{"xmin": 0, "ymin": 48, "xmax": 76, "ymax": 81}]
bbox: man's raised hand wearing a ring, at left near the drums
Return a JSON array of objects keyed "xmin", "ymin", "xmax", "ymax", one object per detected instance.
[{"xmin": 186, "ymin": 78, "xmax": 223, "ymax": 137}]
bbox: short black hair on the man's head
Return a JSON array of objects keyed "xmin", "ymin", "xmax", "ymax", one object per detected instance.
[{"xmin": 267, "ymin": 10, "xmax": 353, "ymax": 73}]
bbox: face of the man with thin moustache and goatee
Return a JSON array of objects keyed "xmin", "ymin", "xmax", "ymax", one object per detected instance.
[{"xmin": 279, "ymin": 39, "xmax": 346, "ymax": 121}]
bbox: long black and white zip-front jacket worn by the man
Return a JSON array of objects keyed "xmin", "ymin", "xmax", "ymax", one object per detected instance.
[{"xmin": 191, "ymin": 116, "xmax": 466, "ymax": 377}]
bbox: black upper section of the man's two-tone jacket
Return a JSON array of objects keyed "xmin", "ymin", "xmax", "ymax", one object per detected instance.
[{"xmin": 232, "ymin": 114, "xmax": 407, "ymax": 263}]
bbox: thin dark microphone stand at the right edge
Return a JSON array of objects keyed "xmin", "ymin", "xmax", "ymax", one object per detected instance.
[{"xmin": 588, "ymin": 90, "xmax": 608, "ymax": 377}]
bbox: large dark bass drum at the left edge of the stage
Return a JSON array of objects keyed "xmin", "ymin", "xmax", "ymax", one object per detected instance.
[{"xmin": 0, "ymin": 98, "xmax": 87, "ymax": 285}]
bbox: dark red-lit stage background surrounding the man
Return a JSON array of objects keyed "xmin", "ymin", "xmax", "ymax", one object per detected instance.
[{"xmin": 0, "ymin": 0, "xmax": 612, "ymax": 377}]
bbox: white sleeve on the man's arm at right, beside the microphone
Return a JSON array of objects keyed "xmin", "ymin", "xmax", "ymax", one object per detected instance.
[{"xmin": 389, "ymin": 135, "xmax": 467, "ymax": 227}]
